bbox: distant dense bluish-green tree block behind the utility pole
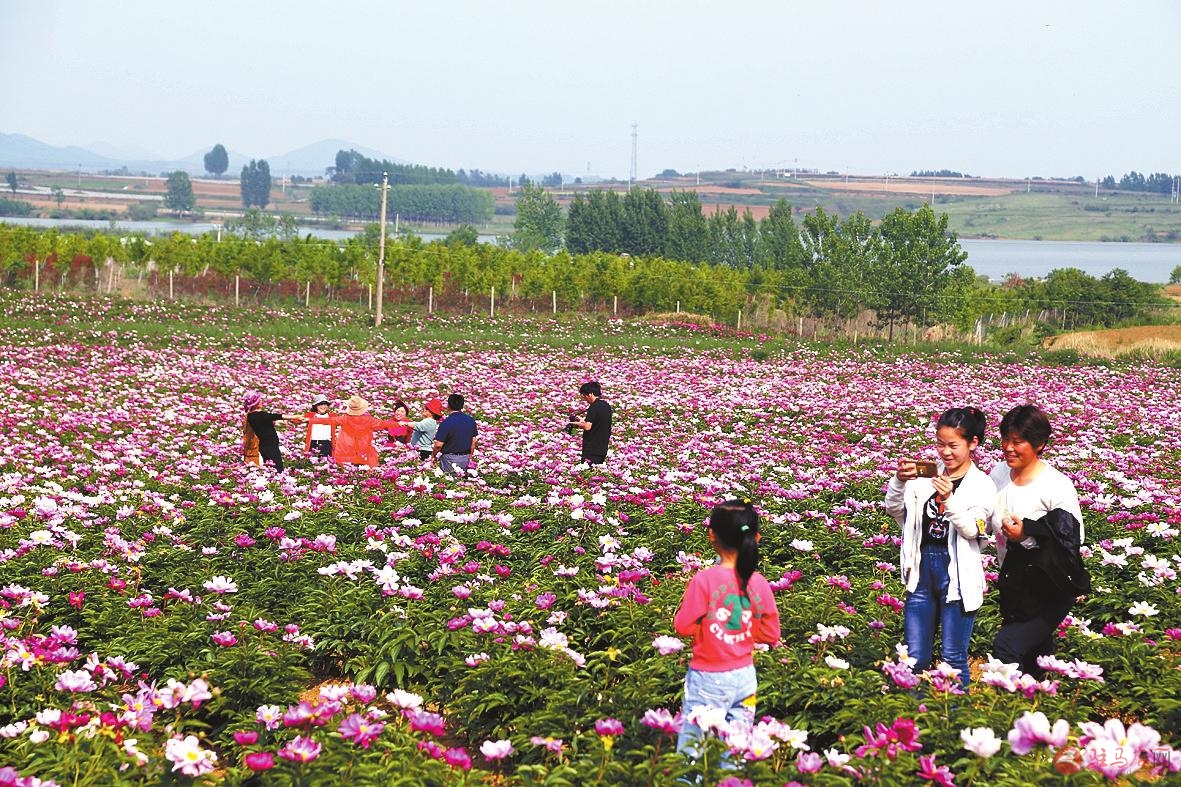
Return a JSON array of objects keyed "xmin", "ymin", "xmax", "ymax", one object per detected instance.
[{"xmin": 308, "ymin": 183, "xmax": 496, "ymax": 223}]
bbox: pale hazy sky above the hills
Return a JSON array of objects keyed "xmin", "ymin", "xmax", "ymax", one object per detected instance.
[{"xmin": 0, "ymin": 0, "xmax": 1181, "ymax": 180}]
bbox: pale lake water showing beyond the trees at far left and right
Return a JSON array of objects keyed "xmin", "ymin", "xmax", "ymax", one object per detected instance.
[{"xmin": 0, "ymin": 217, "xmax": 1181, "ymax": 284}]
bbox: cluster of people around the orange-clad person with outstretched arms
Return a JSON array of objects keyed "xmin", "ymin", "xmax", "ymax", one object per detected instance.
[{"xmin": 242, "ymin": 391, "xmax": 478, "ymax": 475}]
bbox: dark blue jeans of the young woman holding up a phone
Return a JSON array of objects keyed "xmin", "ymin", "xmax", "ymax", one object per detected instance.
[{"xmin": 903, "ymin": 546, "xmax": 976, "ymax": 688}]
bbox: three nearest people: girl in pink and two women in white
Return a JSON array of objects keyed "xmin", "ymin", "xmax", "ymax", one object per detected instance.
[{"xmin": 674, "ymin": 404, "xmax": 1090, "ymax": 756}]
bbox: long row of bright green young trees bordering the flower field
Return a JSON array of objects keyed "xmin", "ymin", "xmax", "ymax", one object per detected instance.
[{"xmin": 0, "ymin": 218, "xmax": 1168, "ymax": 333}]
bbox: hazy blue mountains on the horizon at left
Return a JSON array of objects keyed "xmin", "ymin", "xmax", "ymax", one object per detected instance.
[{"xmin": 0, "ymin": 132, "xmax": 411, "ymax": 176}]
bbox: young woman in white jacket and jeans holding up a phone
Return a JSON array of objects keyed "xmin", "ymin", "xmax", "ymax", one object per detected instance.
[{"xmin": 886, "ymin": 408, "xmax": 997, "ymax": 688}]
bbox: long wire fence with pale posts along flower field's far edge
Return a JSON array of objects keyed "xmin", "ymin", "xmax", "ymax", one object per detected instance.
[{"xmin": 4, "ymin": 258, "xmax": 1181, "ymax": 344}]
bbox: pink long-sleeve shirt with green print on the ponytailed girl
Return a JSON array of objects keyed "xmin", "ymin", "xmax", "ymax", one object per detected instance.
[{"xmin": 673, "ymin": 565, "xmax": 779, "ymax": 672}]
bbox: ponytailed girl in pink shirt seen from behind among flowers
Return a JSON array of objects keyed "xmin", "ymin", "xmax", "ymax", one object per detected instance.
[{"xmin": 673, "ymin": 500, "xmax": 779, "ymax": 757}]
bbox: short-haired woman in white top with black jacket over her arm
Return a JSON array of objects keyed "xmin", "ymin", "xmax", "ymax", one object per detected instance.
[{"xmin": 992, "ymin": 404, "xmax": 1089, "ymax": 678}]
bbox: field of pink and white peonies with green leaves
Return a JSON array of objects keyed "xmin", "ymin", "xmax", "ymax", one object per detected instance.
[{"xmin": 0, "ymin": 298, "xmax": 1181, "ymax": 787}]
